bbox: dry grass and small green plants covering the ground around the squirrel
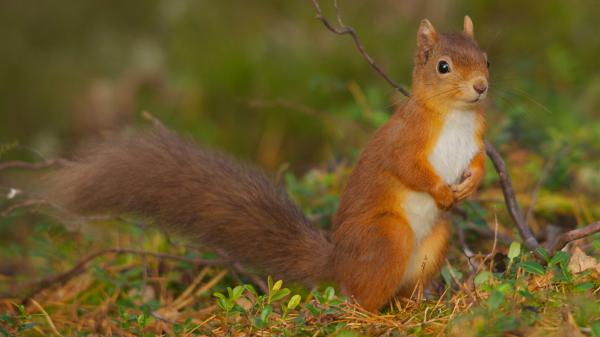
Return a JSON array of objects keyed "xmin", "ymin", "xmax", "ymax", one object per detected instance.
[{"xmin": 0, "ymin": 166, "xmax": 600, "ymax": 337}]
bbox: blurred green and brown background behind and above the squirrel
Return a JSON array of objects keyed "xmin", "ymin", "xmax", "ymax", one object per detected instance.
[{"xmin": 0, "ymin": 0, "xmax": 600, "ymax": 195}]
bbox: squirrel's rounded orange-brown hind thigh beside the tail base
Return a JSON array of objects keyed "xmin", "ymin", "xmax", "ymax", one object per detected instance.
[{"xmin": 333, "ymin": 214, "xmax": 414, "ymax": 311}]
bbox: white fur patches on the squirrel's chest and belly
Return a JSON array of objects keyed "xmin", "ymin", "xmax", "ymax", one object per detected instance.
[{"xmin": 402, "ymin": 110, "xmax": 478, "ymax": 244}]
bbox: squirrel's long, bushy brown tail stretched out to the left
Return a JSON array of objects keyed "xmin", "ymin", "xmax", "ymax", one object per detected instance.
[{"xmin": 49, "ymin": 128, "xmax": 332, "ymax": 283}]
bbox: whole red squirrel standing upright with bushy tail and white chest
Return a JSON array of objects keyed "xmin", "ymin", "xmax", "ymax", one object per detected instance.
[{"xmin": 48, "ymin": 16, "xmax": 489, "ymax": 311}]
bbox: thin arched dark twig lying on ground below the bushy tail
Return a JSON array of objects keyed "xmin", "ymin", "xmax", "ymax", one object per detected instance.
[{"xmin": 23, "ymin": 248, "xmax": 228, "ymax": 303}]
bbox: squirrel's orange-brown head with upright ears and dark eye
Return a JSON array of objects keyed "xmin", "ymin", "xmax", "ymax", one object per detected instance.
[{"xmin": 413, "ymin": 16, "xmax": 489, "ymax": 110}]
